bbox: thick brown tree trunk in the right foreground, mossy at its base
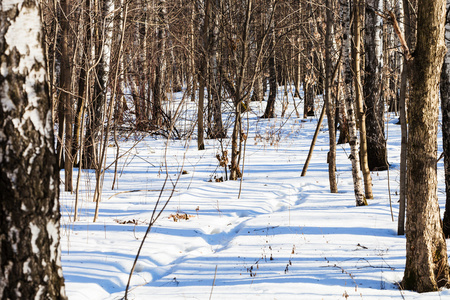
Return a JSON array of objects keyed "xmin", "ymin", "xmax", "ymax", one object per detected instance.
[{"xmin": 402, "ymin": 0, "xmax": 449, "ymax": 292}]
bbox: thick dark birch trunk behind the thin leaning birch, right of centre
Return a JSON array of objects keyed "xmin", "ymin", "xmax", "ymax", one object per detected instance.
[{"xmin": 364, "ymin": 0, "xmax": 388, "ymax": 171}]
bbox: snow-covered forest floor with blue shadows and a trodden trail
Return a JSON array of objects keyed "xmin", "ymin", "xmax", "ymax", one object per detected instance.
[{"xmin": 60, "ymin": 89, "xmax": 450, "ymax": 300}]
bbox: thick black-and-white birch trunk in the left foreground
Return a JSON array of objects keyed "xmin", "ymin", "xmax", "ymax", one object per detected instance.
[{"xmin": 0, "ymin": 0, "xmax": 66, "ymax": 299}]
